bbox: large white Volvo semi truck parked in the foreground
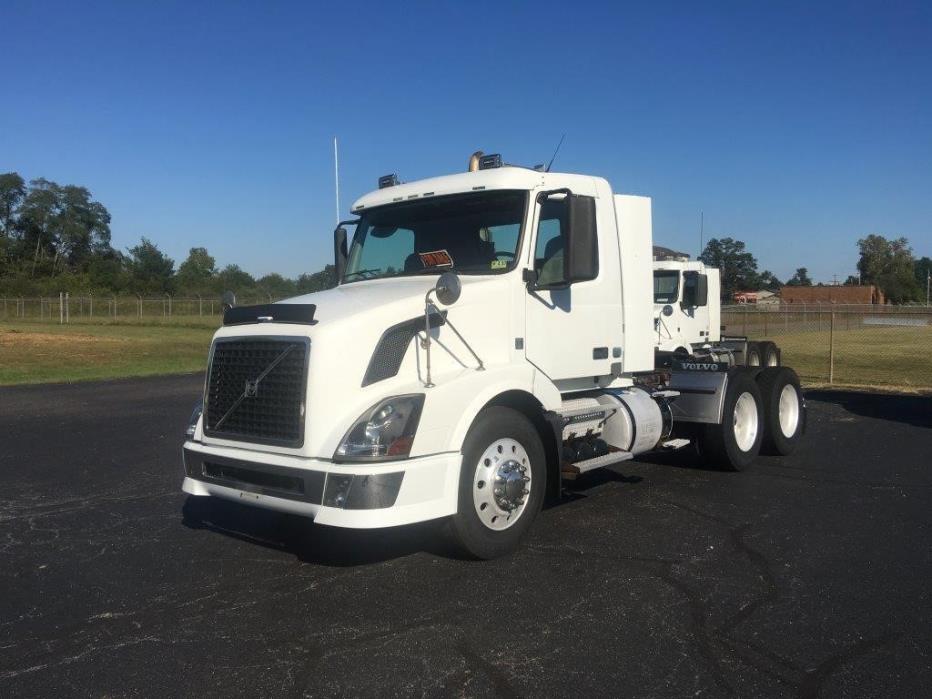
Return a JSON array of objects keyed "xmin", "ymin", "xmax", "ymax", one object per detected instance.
[{"xmin": 183, "ymin": 156, "xmax": 805, "ymax": 558}]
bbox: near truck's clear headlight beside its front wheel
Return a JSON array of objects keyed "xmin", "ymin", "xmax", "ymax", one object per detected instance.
[{"xmin": 333, "ymin": 393, "xmax": 424, "ymax": 461}]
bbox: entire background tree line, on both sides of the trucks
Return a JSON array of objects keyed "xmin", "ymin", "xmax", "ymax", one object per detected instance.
[{"xmin": 0, "ymin": 172, "xmax": 932, "ymax": 303}]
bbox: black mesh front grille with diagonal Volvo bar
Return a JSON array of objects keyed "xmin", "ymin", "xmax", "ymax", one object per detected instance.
[{"xmin": 204, "ymin": 338, "xmax": 309, "ymax": 447}]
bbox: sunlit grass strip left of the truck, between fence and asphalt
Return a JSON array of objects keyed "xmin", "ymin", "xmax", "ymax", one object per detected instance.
[{"xmin": 0, "ymin": 322, "xmax": 214, "ymax": 385}]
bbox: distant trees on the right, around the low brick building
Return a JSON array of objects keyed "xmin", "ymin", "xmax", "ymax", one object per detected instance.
[{"xmin": 699, "ymin": 234, "xmax": 932, "ymax": 303}]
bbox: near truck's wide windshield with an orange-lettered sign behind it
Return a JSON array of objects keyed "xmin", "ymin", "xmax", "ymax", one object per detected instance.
[{"xmin": 343, "ymin": 190, "xmax": 527, "ymax": 282}]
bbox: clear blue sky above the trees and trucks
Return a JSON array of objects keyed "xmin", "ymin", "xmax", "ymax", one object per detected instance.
[{"xmin": 0, "ymin": 0, "xmax": 932, "ymax": 281}]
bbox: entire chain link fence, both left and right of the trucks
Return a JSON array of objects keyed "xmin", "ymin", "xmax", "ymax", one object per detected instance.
[{"xmin": 0, "ymin": 294, "xmax": 932, "ymax": 389}]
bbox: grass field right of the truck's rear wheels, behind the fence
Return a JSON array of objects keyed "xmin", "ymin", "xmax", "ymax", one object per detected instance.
[{"xmin": 748, "ymin": 326, "xmax": 932, "ymax": 389}]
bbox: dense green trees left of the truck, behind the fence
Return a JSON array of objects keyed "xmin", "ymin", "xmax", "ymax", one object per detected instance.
[{"xmin": 0, "ymin": 172, "xmax": 336, "ymax": 298}]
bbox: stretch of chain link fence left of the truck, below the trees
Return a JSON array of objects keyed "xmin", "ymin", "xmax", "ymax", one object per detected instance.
[{"xmin": 0, "ymin": 294, "xmax": 278, "ymax": 326}]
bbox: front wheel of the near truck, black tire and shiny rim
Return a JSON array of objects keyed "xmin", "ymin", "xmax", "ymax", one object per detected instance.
[{"xmin": 450, "ymin": 406, "xmax": 547, "ymax": 559}]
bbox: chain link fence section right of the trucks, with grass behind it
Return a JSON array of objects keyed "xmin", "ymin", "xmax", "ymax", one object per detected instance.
[{"xmin": 722, "ymin": 304, "xmax": 932, "ymax": 389}]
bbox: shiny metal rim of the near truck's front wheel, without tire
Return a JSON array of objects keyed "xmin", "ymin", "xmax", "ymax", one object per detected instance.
[{"xmin": 472, "ymin": 438, "xmax": 532, "ymax": 531}]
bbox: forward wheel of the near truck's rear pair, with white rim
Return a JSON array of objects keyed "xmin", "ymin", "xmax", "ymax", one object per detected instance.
[{"xmin": 699, "ymin": 367, "xmax": 764, "ymax": 471}]
